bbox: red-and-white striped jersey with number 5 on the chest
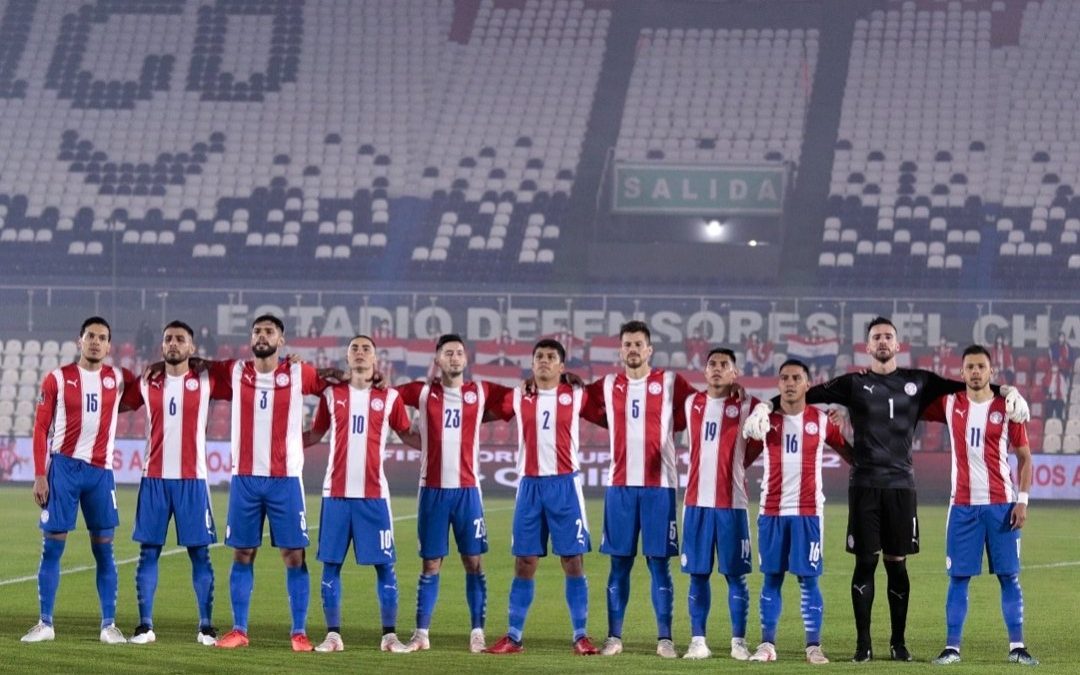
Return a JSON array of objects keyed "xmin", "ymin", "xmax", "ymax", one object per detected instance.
[{"xmin": 585, "ymin": 368, "xmax": 694, "ymax": 488}]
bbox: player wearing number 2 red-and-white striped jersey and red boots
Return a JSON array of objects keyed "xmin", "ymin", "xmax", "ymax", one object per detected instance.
[{"xmin": 485, "ymin": 339, "xmax": 596, "ymax": 656}]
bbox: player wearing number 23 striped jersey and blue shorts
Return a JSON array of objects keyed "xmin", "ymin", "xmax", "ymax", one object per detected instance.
[{"xmin": 396, "ymin": 334, "xmax": 507, "ymax": 653}]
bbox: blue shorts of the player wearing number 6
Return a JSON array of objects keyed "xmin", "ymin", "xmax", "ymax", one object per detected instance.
[{"xmin": 132, "ymin": 478, "xmax": 217, "ymax": 546}]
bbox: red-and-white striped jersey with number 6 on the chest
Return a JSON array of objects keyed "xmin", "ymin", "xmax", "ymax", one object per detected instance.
[{"xmin": 133, "ymin": 370, "xmax": 228, "ymax": 480}]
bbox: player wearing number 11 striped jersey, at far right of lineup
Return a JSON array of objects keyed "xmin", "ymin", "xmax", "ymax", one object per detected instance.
[{"xmin": 923, "ymin": 345, "xmax": 1039, "ymax": 665}]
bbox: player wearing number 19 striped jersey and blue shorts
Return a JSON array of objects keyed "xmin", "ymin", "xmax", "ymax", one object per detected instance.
[{"xmin": 681, "ymin": 348, "xmax": 758, "ymax": 661}]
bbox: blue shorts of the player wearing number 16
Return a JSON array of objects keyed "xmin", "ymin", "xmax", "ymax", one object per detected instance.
[{"xmin": 757, "ymin": 515, "xmax": 825, "ymax": 577}]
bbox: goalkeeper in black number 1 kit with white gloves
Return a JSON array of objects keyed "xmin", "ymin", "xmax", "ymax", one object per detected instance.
[{"xmin": 743, "ymin": 316, "xmax": 1030, "ymax": 662}]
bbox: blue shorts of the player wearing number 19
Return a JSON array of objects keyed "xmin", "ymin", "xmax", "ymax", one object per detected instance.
[{"xmin": 681, "ymin": 507, "xmax": 751, "ymax": 576}]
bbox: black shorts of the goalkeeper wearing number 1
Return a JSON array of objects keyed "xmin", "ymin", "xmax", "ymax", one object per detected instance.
[{"xmin": 847, "ymin": 485, "xmax": 919, "ymax": 555}]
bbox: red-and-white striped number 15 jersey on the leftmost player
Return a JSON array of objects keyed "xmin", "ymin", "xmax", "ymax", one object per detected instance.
[{"xmin": 33, "ymin": 363, "xmax": 137, "ymax": 476}]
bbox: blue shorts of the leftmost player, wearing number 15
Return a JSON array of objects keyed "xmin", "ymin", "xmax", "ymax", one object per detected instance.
[{"xmin": 38, "ymin": 453, "xmax": 120, "ymax": 532}]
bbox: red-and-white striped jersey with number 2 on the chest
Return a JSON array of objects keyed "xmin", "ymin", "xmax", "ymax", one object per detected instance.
[{"xmin": 498, "ymin": 384, "xmax": 588, "ymax": 476}]
